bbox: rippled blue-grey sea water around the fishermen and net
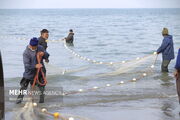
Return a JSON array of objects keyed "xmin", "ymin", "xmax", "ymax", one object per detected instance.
[{"xmin": 0, "ymin": 9, "xmax": 180, "ymax": 120}]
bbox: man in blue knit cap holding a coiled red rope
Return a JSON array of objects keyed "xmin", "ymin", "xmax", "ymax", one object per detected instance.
[{"xmin": 16, "ymin": 37, "xmax": 49, "ymax": 104}]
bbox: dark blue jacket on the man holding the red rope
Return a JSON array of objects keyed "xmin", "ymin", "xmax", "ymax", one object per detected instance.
[{"xmin": 23, "ymin": 45, "xmax": 49, "ymax": 80}]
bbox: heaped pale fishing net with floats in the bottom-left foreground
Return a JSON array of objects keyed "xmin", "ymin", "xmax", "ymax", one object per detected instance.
[{"xmin": 14, "ymin": 101, "xmax": 93, "ymax": 120}]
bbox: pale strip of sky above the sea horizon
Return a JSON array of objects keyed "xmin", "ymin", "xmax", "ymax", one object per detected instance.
[{"xmin": 0, "ymin": 0, "xmax": 180, "ymax": 9}]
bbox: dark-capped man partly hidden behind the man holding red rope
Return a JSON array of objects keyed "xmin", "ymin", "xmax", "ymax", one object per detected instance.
[{"xmin": 38, "ymin": 29, "xmax": 49, "ymax": 63}]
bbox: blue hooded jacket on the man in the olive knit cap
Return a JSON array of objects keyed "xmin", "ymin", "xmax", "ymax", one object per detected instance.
[{"xmin": 157, "ymin": 35, "xmax": 174, "ymax": 60}]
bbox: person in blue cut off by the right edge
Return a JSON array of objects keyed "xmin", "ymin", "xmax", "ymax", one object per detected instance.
[{"xmin": 175, "ymin": 48, "xmax": 180, "ymax": 104}]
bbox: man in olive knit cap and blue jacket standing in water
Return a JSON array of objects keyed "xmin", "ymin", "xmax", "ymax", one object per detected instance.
[{"xmin": 157, "ymin": 28, "xmax": 174, "ymax": 72}]
